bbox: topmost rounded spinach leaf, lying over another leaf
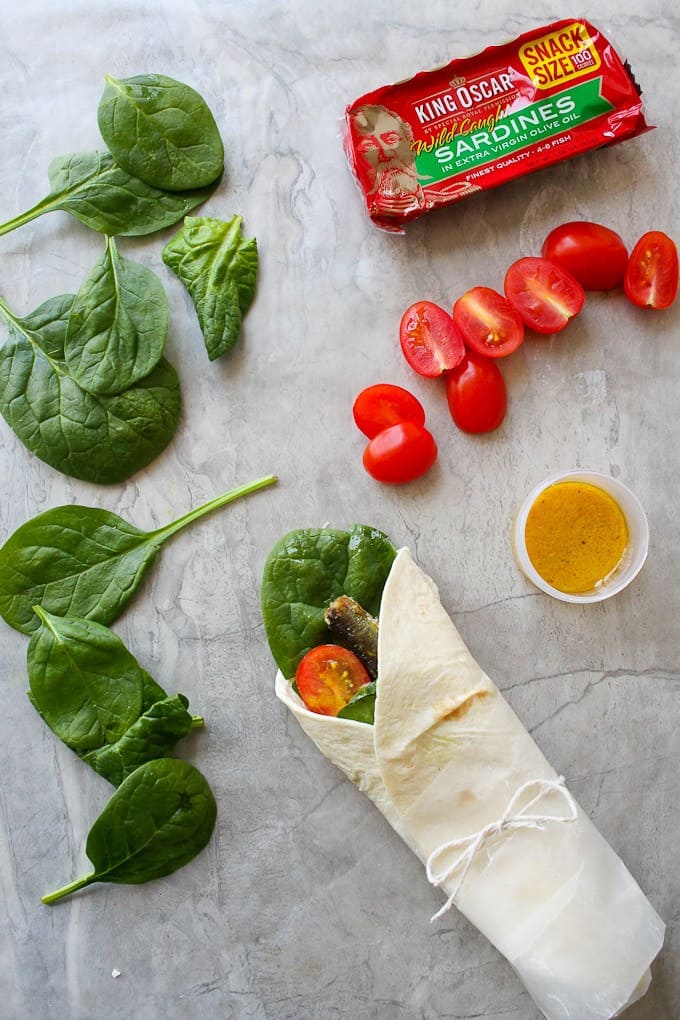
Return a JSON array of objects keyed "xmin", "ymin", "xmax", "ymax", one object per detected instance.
[{"xmin": 97, "ymin": 74, "xmax": 224, "ymax": 191}]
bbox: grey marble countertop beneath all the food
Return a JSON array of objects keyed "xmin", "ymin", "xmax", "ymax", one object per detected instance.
[{"xmin": 0, "ymin": 0, "xmax": 680, "ymax": 1020}]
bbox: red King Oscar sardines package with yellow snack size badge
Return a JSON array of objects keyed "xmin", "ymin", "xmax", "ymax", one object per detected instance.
[{"xmin": 345, "ymin": 18, "xmax": 649, "ymax": 232}]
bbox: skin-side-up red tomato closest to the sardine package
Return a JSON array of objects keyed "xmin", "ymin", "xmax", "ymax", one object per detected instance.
[{"xmin": 541, "ymin": 220, "xmax": 628, "ymax": 291}]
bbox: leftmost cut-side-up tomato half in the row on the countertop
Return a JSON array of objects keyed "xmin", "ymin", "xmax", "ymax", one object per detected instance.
[{"xmin": 399, "ymin": 301, "xmax": 465, "ymax": 378}]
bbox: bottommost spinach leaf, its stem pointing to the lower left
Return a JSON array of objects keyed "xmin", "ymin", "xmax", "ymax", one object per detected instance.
[{"xmin": 42, "ymin": 758, "xmax": 217, "ymax": 903}]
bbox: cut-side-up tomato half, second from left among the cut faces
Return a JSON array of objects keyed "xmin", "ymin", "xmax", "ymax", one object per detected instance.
[{"xmin": 454, "ymin": 287, "xmax": 524, "ymax": 358}]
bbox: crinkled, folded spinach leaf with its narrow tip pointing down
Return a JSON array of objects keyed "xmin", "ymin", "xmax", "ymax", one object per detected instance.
[{"xmin": 163, "ymin": 216, "xmax": 258, "ymax": 361}]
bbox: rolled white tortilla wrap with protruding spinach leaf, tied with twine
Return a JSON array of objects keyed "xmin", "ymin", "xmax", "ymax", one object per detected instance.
[{"xmin": 262, "ymin": 527, "xmax": 665, "ymax": 1020}]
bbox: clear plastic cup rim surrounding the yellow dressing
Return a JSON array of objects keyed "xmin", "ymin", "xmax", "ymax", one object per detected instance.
[{"xmin": 512, "ymin": 471, "xmax": 649, "ymax": 603}]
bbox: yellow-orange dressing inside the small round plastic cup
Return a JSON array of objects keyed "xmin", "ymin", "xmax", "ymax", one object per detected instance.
[{"xmin": 524, "ymin": 481, "xmax": 628, "ymax": 595}]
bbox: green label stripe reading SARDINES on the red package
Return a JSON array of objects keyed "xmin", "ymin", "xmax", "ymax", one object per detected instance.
[{"xmin": 415, "ymin": 78, "xmax": 614, "ymax": 186}]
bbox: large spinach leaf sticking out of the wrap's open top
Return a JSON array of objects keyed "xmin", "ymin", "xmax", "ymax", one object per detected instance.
[{"xmin": 260, "ymin": 524, "xmax": 396, "ymax": 678}]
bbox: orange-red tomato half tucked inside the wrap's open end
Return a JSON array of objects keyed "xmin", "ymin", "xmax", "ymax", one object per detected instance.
[{"xmin": 296, "ymin": 645, "xmax": 371, "ymax": 715}]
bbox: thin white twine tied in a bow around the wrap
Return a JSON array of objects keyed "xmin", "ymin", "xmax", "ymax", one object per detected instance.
[{"xmin": 425, "ymin": 775, "xmax": 578, "ymax": 921}]
